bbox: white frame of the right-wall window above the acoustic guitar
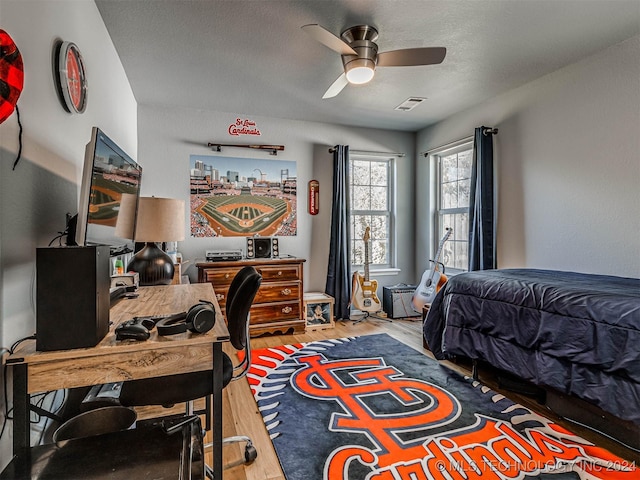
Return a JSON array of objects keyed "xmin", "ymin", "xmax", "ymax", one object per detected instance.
[{"xmin": 429, "ymin": 137, "xmax": 473, "ymax": 275}]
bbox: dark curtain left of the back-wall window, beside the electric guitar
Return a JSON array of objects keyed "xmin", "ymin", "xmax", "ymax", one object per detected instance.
[{"xmin": 325, "ymin": 145, "xmax": 351, "ymax": 320}]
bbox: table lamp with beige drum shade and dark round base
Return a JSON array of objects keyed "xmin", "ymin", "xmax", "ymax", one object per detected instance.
[{"xmin": 121, "ymin": 197, "xmax": 185, "ymax": 285}]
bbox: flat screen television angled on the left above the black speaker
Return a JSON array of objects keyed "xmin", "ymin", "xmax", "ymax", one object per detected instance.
[{"xmin": 75, "ymin": 127, "xmax": 142, "ymax": 255}]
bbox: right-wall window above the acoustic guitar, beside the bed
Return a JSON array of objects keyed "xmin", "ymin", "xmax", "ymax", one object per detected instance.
[{"xmin": 433, "ymin": 141, "xmax": 473, "ymax": 271}]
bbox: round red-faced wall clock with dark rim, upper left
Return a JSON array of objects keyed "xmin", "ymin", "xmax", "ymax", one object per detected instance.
[{"xmin": 55, "ymin": 42, "xmax": 88, "ymax": 113}]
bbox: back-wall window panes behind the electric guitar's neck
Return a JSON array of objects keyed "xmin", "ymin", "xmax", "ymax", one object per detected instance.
[{"xmin": 349, "ymin": 158, "xmax": 393, "ymax": 268}]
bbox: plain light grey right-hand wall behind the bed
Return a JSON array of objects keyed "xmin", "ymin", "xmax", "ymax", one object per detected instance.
[{"xmin": 416, "ymin": 36, "xmax": 640, "ymax": 277}]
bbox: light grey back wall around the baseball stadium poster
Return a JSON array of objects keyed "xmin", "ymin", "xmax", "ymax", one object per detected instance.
[{"xmin": 138, "ymin": 105, "xmax": 415, "ymax": 291}]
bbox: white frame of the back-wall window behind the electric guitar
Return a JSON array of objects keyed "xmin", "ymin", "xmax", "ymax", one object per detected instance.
[{"xmin": 348, "ymin": 152, "xmax": 396, "ymax": 276}]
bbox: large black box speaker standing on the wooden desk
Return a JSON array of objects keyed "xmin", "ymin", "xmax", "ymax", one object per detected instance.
[{"xmin": 36, "ymin": 245, "xmax": 111, "ymax": 351}]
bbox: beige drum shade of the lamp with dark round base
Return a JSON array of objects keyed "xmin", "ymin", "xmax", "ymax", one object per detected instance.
[{"xmin": 135, "ymin": 197, "xmax": 185, "ymax": 242}]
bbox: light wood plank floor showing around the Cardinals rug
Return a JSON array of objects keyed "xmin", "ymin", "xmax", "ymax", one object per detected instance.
[{"xmin": 209, "ymin": 319, "xmax": 640, "ymax": 480}]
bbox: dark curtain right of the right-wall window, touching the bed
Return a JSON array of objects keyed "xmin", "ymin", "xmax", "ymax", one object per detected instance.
[{"xmin": 469, "ymin": 127, "xmax": 497, "ymax": 271}]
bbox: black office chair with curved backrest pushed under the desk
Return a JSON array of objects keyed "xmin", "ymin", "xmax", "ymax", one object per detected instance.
[{"xmin": 120, "ymin": 267, "xmax": 262, "ymax": 476}]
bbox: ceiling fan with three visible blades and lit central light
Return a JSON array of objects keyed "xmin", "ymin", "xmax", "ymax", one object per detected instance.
[{"xmin": 302, "ymin": 24, "xmax": 447, "ymax": 98}]
